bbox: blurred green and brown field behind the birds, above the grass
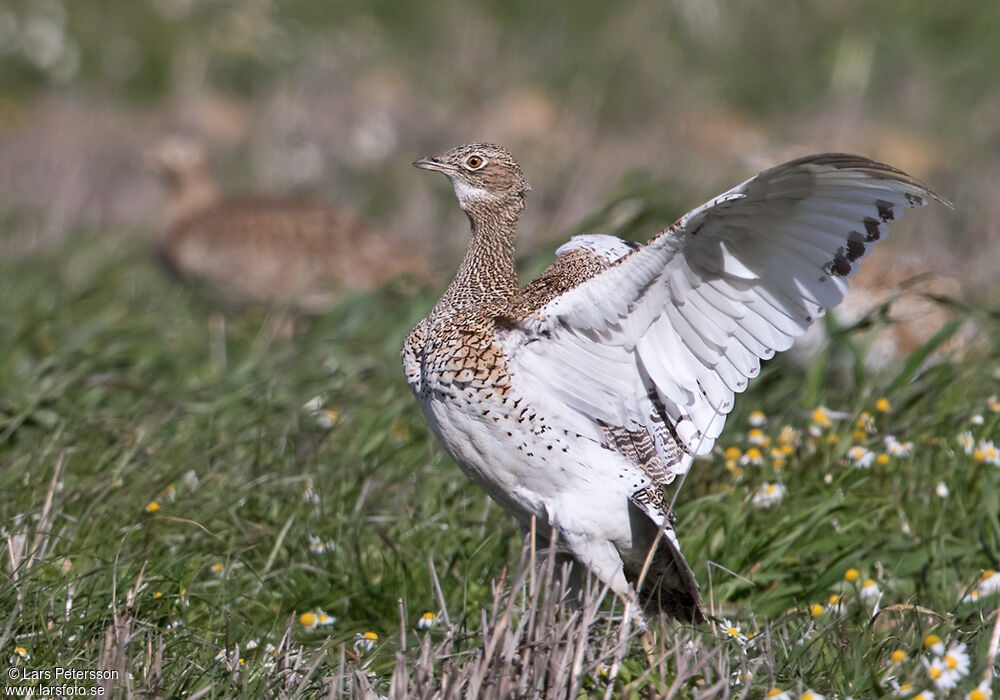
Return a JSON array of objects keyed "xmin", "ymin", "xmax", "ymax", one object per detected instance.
[{"xmin": 0, "ymin": 0, "xmax": 1000, "ymax": 289}]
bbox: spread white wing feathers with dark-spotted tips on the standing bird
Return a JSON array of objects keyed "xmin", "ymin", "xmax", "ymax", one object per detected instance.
[{"xmin": 505, "ymin": 154, "xmax": 939, "ymax": 479}]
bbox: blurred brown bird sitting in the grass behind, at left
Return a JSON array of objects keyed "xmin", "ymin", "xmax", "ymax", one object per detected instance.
[{"xmin": 146, "ymin": 137, "xmax": 430, "ymax": 313}]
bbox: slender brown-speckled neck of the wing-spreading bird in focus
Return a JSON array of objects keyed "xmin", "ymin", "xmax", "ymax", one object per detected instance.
[{"xmin": 441, "ymin": 195, "xmax": 524, "ymax": 308}]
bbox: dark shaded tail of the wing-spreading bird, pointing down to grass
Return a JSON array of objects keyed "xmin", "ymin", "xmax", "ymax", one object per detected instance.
[{"xmin": 623, "ymin": 500, "xmax": 705, "ymax": 624}]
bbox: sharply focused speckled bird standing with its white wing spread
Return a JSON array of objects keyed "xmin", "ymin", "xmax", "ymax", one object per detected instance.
[{"xmin": 402, "ymin": 143, "xmax": 939, "ymax": 623}]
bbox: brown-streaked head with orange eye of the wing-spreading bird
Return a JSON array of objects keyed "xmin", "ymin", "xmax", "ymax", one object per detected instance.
[{"xmin": 413, "ymin": 143, "xmax": 531, "ymax": 211}]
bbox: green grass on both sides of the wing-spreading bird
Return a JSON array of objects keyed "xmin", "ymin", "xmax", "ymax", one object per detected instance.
[{"xmin": 0, "ymin": 232, "xmax": 1000, "ymax": 697}]
